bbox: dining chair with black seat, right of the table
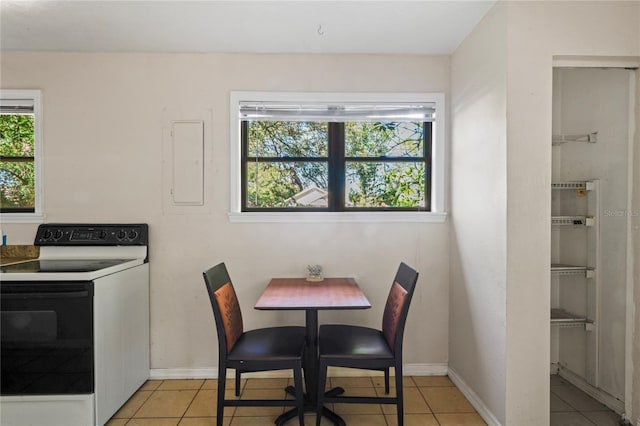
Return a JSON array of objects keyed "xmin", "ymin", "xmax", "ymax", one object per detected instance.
[{"xmin": 316, "ymin": 263, "xmax": 418, "ymax": 426}]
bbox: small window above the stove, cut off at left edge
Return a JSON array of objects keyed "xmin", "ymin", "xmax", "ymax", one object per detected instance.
[{"xmin": 0, "ymin": 90, "xmax": 42, "ymax": 222}]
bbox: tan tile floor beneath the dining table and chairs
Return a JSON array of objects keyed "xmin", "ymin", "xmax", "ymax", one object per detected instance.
[{"xmin": 107, "ymin": 376, "xmax": 485, "ymax": 426}]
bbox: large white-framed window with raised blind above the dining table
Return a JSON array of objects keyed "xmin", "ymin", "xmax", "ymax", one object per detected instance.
[{"xmin": 231, "ymin": 92, "xmax": 444, "ymax": 221}]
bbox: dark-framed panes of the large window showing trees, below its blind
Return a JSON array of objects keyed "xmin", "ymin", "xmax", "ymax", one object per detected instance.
[{"xmin": 241, "ymin": 120, "xmax": 431, "ymax": 211}]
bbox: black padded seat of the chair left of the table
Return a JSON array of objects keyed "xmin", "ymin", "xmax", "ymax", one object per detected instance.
[{"xmin": 227, "ymin": 327, "xmax": 306, "ymax": 361}]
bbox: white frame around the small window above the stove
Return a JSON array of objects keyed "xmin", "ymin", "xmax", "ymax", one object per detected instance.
[{"xmin": 0, "ymin": 89, "xmax": 44, "ymax": 223}]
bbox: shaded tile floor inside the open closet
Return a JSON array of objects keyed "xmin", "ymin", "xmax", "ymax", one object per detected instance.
[{"xmin": 550, "ymin": 375, "xmax": 620, "ymax": 426}]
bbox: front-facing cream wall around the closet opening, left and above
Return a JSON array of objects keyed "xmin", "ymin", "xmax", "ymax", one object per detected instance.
[{"xmin": 507, "ymin": 1, "xmax": 640, "ymax": 425}]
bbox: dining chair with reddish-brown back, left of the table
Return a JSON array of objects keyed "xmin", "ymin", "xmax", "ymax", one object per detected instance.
[{"xmin": 203, "ymin": 263, "xmax": 305, "ymax": 426}]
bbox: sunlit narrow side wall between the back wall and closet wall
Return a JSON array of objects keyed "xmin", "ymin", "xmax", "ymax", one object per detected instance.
[{"xmin": 449, "ymin": 4, "xmax": 507, "ymax": 424}]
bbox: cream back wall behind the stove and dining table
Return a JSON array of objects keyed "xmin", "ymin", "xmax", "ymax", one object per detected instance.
[{"xmin": 0, "ymin": 52, "xmax": 449, "ymax": 374}]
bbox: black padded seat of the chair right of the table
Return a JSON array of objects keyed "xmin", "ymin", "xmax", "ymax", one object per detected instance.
[{"xmin": 318, "ymin": 324, "xmax": 394, "ymax": 360}]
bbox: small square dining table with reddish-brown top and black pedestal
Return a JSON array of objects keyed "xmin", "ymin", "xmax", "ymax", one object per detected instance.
[{"xmin": 255, "ymin": 278, "xmax": 371, "ymax": 426}]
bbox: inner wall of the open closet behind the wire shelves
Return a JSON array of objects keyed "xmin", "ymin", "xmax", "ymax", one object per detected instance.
[{"xmin": 551, "ymin": 68, "xmax": 635, "ymax": 401}]
